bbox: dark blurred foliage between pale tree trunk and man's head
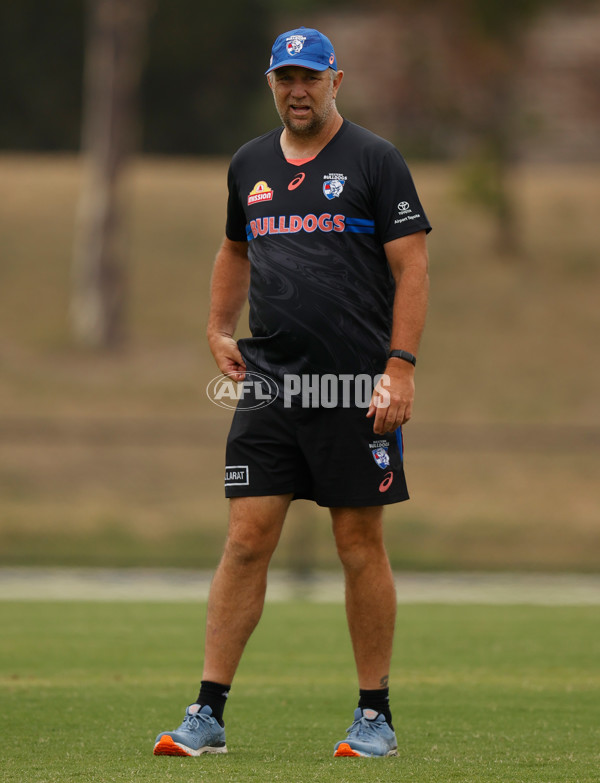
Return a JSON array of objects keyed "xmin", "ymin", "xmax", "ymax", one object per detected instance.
[{"xmin": 142, "ymin": 0, "xmax": 271, "ymax": 154}]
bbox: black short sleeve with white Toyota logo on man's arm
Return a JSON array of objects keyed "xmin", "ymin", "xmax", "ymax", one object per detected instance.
[{"xmin": 374, "ymin": 148, "xmax": 431, "ymax": 244}]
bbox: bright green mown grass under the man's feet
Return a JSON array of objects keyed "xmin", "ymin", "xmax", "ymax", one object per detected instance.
[{"xmin": 0, "ymin": 602, "xmax": 600, "ymax": 783}]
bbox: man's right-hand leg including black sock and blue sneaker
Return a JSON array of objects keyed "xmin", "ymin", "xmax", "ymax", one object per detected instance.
[{"xmin": 331, "ymin": 506, "xmax": 397, "ymax": 756}]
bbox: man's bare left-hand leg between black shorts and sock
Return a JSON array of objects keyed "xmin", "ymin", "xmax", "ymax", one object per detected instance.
[{"xmin": 202, "ymin": 495, "xmax": 292, "ymax": 685}]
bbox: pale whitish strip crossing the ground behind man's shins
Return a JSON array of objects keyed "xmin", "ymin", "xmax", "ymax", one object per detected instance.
[{"xmin": 0, "ymin": 567, "xmax": 600, "ymax": 606}]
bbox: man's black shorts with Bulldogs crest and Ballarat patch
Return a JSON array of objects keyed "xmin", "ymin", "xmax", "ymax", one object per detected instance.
[{"xmin": 225, "ymin": 390, "xmax": 408, "ymax": 508}]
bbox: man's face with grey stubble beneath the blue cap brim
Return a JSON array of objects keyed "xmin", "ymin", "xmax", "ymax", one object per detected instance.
[{"xmin": 271, "ymin": 65, "xmax": 342, "ymax": 136}]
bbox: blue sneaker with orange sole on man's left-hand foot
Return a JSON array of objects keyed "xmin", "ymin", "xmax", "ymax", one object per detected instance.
[{"xmin": 154, "ymin": 704, "xmax": 227, "ymax": 756}]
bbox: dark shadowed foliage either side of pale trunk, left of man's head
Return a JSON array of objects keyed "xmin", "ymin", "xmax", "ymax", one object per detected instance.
[{"xmin": 0, "ymin": 0, "xmax": 276, "ymax": 154}]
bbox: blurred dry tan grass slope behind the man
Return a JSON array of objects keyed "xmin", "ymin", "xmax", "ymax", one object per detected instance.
[{"xmin": 0, "ymin": 157, "xmax": 600, "ymax": 569}]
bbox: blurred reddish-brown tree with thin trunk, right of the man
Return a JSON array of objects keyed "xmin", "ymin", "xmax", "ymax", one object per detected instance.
[{"xmin": 364, "ymin": 0, "xmax": 591, "ymax": 255}]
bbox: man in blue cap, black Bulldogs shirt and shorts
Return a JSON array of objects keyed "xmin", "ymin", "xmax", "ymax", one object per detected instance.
[{"xmin": 154, "ymin": 28, "xmax": 430, "ymax": 756}]
